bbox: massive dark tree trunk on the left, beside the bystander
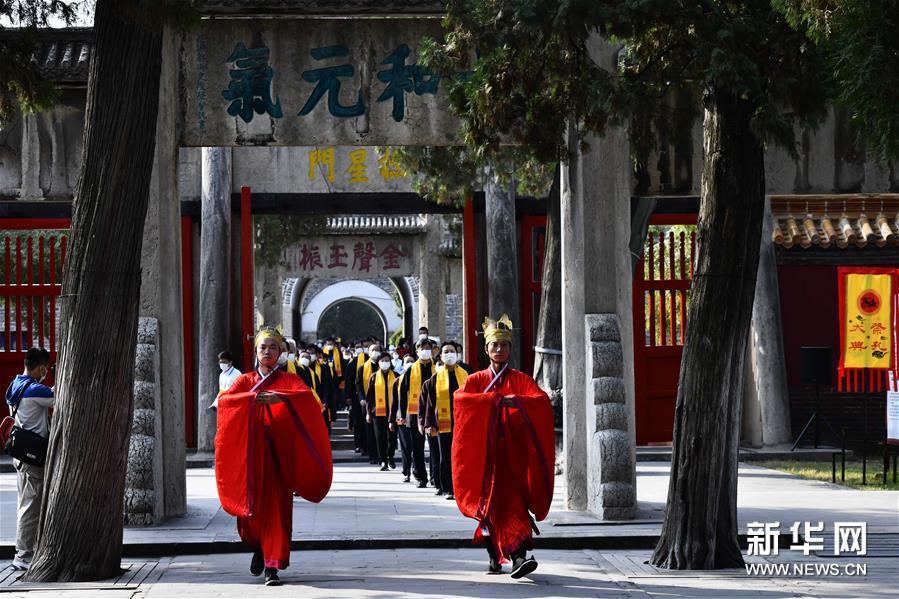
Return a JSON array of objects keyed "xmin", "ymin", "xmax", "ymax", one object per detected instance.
[{"xmin": 27, "ymin": 0, "xmax": 163, "ymax": 582}]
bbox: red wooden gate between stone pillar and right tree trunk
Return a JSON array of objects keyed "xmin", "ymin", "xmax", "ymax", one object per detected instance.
[{"xmin": 633, "ymin": 214, "xmax": 696, "ymax": 445}]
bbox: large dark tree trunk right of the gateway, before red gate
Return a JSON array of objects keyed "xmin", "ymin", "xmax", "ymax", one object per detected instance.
[{"xmin": 651, "ymin": 90, "xmax": 765, "ymax": 570}]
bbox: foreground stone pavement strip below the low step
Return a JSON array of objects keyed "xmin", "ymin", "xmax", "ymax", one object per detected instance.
[{"xmin": 0, "ymin": 549, "xmax": 899, "ymax": 599}]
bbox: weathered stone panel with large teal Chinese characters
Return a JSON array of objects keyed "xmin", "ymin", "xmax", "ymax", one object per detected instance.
[{"xmin": 179, "ymin": 18, "xmax": 461, "ymax": 146}]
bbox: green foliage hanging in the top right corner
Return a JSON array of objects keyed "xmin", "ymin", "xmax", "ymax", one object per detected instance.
[{"xmin": 775, "ymin": 0, "xmax": 899, "ymax": 161}]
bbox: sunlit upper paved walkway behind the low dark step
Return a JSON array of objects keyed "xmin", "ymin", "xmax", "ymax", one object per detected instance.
[{"xmin": 0, "ymin": 462, "xmax": 899, "ymax": 559}]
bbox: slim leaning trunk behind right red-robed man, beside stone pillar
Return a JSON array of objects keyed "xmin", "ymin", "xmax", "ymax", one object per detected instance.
[{"xmin": 534, "ymin": 167, "xmax": 562, "ymax": 426}]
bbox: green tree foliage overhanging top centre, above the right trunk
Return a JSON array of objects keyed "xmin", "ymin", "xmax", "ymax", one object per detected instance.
[{"xmin": 422, "ymin": 0, "xmax": 825, "ymax": 161}]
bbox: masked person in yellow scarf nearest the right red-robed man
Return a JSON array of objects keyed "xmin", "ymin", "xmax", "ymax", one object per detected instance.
[{"xmin": 419, "ymin": 341, "xmax": 469, "ymax": 499}]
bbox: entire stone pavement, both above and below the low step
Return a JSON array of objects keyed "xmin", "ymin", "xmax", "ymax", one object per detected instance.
[{"xmin": 0, "ymin": 462, "xmax": 899, "ymax": 599}]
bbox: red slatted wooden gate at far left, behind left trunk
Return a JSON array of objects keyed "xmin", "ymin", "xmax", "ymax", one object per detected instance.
[{"xmin": 0, "ymin": 219, "xmax": 69, "ymax": 414}]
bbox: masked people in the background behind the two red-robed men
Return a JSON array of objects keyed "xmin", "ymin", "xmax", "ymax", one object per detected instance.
[{"xmin": 212, "ymin": 327, "xmax": 472, "ymax": 499}]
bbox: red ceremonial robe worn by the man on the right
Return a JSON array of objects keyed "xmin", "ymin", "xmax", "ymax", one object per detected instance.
[{"xmin": 452, "ymin": 368, "xmax": 555, "ymax": 563}]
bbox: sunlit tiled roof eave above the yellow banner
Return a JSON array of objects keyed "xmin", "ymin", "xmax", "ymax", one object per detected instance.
[{"xmin": 771, "ymin": 193, "xmax": 899, "ymax": 249}]
